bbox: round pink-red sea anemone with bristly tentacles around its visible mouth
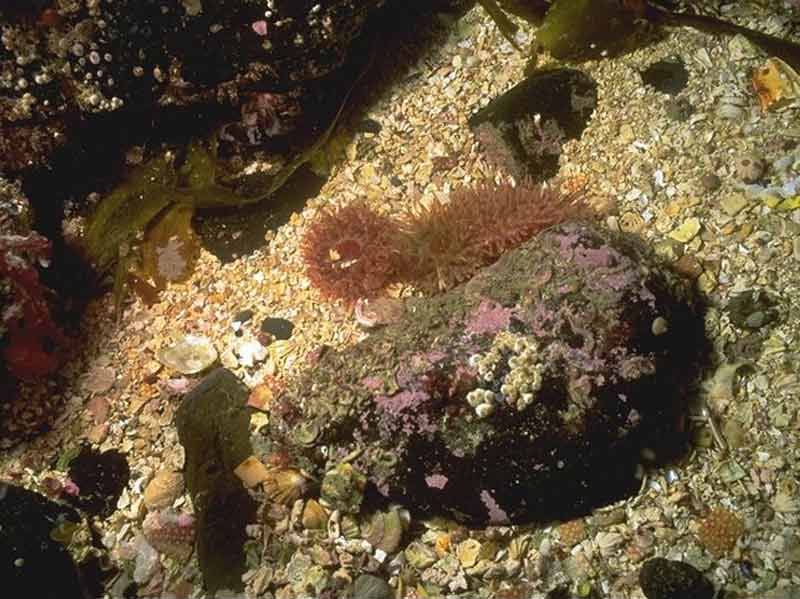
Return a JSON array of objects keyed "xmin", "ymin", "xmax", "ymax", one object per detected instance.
[{"xmin": 301, "ymin": 203, "xmax": 397, "ymax": 304}]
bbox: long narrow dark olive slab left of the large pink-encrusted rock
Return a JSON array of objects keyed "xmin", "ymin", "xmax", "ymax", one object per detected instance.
[{"xmin": 176, "ymin": 368, "xmax": 255, "ymax": 592}]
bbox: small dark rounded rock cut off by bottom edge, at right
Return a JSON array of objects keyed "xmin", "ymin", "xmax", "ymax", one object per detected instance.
[{"xmin": 639, "ymin": 557, "xmax": 714, "ymax": 599}]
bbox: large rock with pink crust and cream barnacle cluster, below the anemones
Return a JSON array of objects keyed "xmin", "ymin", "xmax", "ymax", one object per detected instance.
[{"xmin": 260, "ymin": 224, "xmax": 706, "ymax": 525}]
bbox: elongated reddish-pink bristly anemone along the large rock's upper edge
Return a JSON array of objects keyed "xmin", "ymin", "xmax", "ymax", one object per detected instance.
[{"xmin": 394, "ymin": 180, "xmax": 590, "ymax": 290}]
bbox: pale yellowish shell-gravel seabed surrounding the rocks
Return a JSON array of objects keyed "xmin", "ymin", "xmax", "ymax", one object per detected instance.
[{"xmin": 0, "ymin": 3, "xmax": 800, "ymax": 599}]
